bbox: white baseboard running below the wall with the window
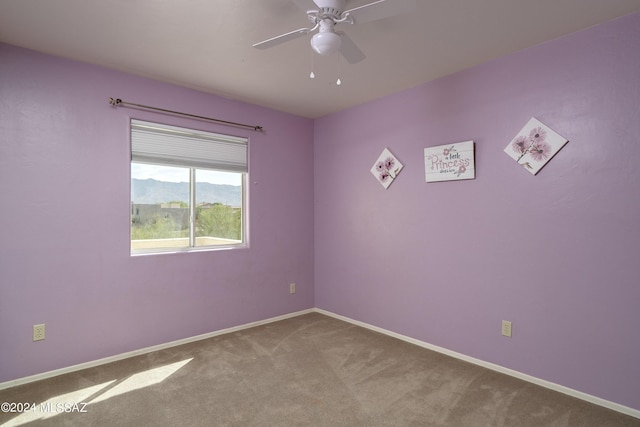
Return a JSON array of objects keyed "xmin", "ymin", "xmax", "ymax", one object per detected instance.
[{"xmin": 0, "ymin": 309, "xmax": 313, "ymax": 390}]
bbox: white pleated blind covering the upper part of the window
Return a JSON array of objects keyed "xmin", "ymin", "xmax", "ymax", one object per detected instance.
[{"xmin": 131, "ymin": 119, "xmax": 247, "ymax": 172}]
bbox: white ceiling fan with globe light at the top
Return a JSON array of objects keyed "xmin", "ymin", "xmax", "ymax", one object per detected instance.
[{"xmin": 253, "ymin": 0, "xmax": 416, "ymax": 64}]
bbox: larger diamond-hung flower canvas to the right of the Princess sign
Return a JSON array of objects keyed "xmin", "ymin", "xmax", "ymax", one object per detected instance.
[{"xmin": 504, "ymin": 117, "xmax": 569, "ymax": 175}]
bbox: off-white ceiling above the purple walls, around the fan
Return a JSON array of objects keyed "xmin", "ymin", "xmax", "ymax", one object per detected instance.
[{"xmin": 0, "ymin": 0, "xmax": 640, "ymax": 118}]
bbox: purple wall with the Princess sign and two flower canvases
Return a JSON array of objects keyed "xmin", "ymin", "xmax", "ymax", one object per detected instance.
[{"xmin": 314, "ymin": 14, "xmax": 640, "ymax": 409}]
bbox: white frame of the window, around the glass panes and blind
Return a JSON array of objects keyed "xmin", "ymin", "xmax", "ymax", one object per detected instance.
[{"xmin": 129, "ymin": 118, "xmax": 249, "ymax": 256}]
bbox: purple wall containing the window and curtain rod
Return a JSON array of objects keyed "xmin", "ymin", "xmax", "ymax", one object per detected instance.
[{"xmin": 0, "ymin": 44, "xmax": 314, "ymax": 382}]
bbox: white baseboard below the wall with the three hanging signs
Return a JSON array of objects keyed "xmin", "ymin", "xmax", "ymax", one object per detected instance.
[{"xmin": 313, "ymin": 308, "xmax": 640, "ymax": 418}]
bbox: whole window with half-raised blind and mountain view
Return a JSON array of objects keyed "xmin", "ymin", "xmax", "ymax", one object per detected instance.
[{"xmin": 131, "ymin": 120, "xmax": 247, "ymax": 254}]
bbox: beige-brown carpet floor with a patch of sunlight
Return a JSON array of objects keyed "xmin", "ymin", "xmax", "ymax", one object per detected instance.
[{"xmin": 0, "ymin": 313, "xmax": 640, "ymax": 427}]
